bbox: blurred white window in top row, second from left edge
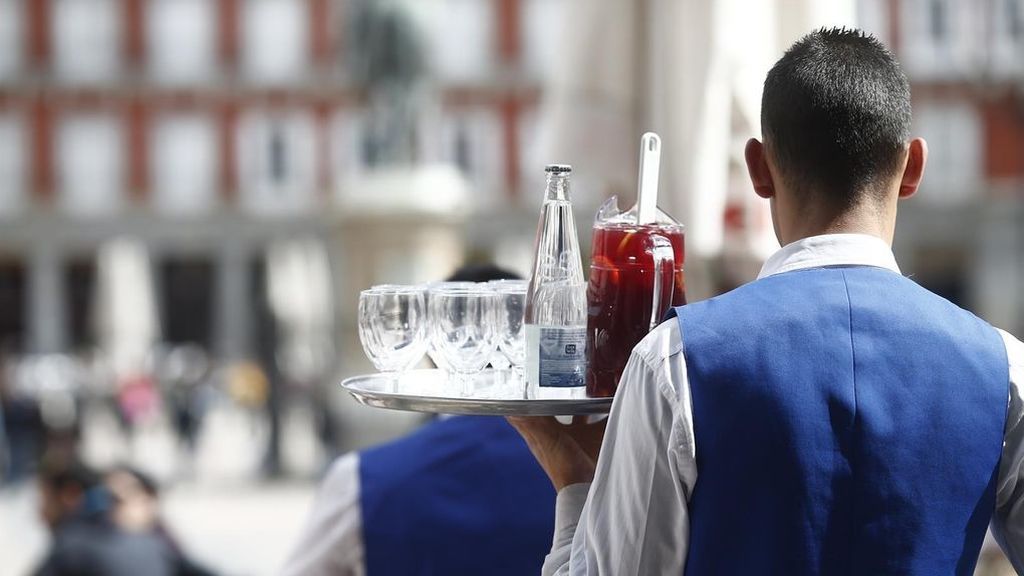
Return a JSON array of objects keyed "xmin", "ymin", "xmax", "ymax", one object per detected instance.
[{"xmin": 52, "ymin": 0, "xmax": 121, "ymax": 83}]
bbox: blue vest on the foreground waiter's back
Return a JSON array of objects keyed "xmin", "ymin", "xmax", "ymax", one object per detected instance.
[{"xmin": 663, "ymin": 266, "xmax": 1009, "ymax": 576}]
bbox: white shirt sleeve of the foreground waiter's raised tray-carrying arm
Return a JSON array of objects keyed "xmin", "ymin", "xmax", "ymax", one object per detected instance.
[{"xmin": 542, "ymin": 323, "xmax": 695, "ymax": 576}]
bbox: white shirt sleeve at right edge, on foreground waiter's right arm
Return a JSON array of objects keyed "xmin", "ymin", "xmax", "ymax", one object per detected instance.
[{"xmin": 991, "ymin": 330, "xmax": 1024, "ymax": 574}]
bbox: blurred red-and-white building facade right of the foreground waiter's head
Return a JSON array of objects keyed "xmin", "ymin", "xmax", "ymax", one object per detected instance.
[{"xmin": 858, "ymin": 0, "xmax": 1024, "ymax": 334}]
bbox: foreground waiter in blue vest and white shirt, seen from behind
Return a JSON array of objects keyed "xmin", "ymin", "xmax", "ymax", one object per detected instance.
[{"xmin": 512, "ymin": 29, "xmax": 1024, "ymax": 576}]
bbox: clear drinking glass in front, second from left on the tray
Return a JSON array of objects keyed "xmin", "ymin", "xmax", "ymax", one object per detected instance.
[{"xmin": 430, "ymin": 287, "xmax": 498, "ymax": 394}]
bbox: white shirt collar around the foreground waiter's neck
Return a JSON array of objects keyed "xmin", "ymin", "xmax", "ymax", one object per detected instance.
[{"xmin": 758, "ymin": 234, "xmax": 900, "ymax": 280}]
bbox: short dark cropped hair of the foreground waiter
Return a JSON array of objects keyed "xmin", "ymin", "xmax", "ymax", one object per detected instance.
[{"xmin": 761, "ymin": 28, "xmax": 910, "ymax": 209}]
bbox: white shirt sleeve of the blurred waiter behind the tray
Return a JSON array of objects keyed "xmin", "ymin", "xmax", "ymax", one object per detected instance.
[{"xmin": 281, "ymin": 452, "xmax": 366, "ymax": 576}]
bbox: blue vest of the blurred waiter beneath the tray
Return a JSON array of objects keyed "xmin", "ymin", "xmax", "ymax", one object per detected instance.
[{"xmin": 359, "ymin": 416, "xmax": 555, "ymax": 576}]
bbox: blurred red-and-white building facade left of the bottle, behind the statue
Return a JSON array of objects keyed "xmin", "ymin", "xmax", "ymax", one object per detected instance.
[{"xmin": 0, "ymin": 0, "xmax": 565, "ymax": 358}]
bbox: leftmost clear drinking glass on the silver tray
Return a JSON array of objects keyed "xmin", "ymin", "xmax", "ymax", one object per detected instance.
[{"xmin": 359, "ymin": 285, "xmax": 427, "ymax": 375}]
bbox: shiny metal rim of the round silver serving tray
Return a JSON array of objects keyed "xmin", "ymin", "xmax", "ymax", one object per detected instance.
[{"xmin": 341, "ymin": 369, "xmax": 613, "ymax": 416}]
